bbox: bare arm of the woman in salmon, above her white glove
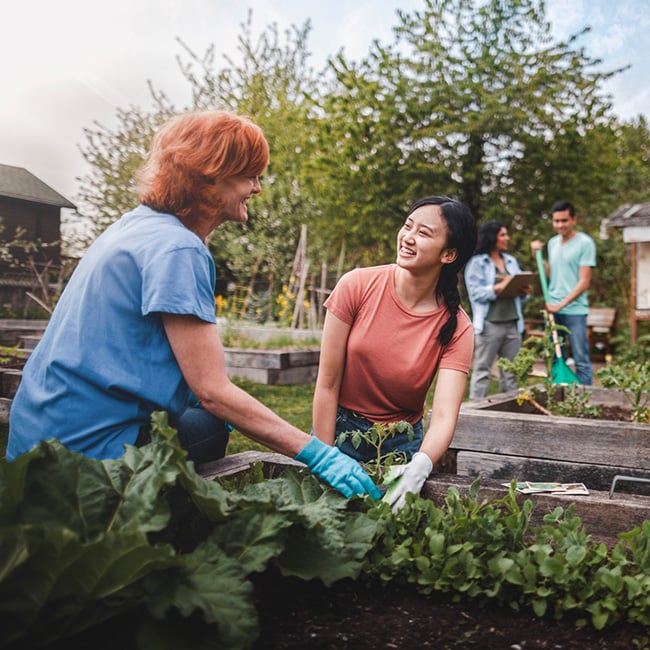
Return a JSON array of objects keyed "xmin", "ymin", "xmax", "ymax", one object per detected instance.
[{"xmin": 420, "ymin": 368, "xmax": 467, "ymax": 463}]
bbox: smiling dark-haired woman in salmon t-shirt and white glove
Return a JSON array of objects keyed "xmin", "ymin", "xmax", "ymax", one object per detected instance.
[{"xmin": 313, "ymin": 196, "xmax": 476, "ymax": 508}]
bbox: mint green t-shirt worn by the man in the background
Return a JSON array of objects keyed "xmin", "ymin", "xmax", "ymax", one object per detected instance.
[{"xmin": 547, "ymin": 232, "xmax": 596, "ymax": 316}]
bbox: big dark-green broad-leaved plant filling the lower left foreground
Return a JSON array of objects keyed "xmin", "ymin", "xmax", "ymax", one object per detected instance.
[{"xmin": 0, "ymin": 413, "xmax": 381, "ymax": 649}]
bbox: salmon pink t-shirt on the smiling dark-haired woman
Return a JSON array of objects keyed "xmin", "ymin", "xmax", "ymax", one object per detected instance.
[{"xmin": 325, "ymin": 264, "xmax": 474, "ymax": 424}]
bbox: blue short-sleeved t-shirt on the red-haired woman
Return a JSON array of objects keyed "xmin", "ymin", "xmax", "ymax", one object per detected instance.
[{"xmin": 7, "ymin": 206, "xmax": 216, "ymax": 460}]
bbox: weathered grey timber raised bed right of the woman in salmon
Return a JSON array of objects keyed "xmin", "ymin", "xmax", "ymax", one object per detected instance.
[{"xmin": 448, "ymin": 386, "xmax": 650, "ymax": 494}]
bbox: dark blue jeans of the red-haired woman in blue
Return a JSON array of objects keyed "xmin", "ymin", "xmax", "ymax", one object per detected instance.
[{"xmin": 135, "ymin": 406, "xmax": 232, "ymax": 465}]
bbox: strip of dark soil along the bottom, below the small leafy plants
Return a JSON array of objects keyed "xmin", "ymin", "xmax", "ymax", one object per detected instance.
[{"xmin": 255, "ymin": 575, "xmax": 650, "ymax": 650}]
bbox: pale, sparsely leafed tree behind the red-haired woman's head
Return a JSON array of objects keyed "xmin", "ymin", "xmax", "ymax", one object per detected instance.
[{"xmin": 81, "ymin": 12, "xmax": 318, "ymax": 318}]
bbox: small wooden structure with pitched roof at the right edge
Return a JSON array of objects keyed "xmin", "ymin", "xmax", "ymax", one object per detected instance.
[{"xmin": 601, "ymin": 203, "xmax": 650, "ymax": 343}]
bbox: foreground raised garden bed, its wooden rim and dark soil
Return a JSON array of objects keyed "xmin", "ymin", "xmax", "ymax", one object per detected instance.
[{"xmin": 199, "ymin": 452, "xmax": 648, "ymax": 650}]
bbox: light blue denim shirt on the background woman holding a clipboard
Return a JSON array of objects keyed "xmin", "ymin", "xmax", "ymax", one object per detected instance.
[{"xmin": 465, "ymin": 253, "xmax": 528, "ymax": 334}]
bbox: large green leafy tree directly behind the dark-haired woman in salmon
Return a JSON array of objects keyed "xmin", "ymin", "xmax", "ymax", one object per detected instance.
[{"xmin": 316, "ymin": 0, "xmax": 616, "ymax": 237}]
